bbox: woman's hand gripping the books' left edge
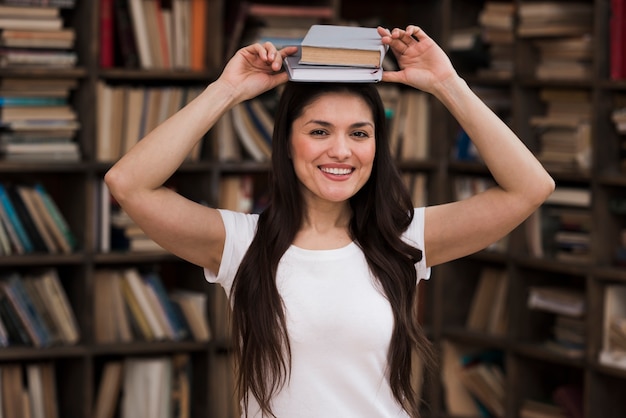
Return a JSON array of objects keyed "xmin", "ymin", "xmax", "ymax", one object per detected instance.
[{"xmin": 218, "ymin": 42, "xmax": 298, "ymax": 102}]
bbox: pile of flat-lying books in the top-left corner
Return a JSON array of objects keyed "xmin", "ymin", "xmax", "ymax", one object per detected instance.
[{"xmin": 0, "ymin": 2, "xmax": 78, "ymax": 68}]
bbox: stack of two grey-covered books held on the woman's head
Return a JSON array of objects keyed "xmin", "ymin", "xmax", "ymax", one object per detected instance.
[{"xmin": 284, "ymin": 25, "xmax": 388, "ymax": 83}]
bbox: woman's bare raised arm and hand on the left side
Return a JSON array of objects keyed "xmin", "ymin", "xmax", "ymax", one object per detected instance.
[{"xmin": 105, "ymin": 43, "xmax": 295, "ymax": 272}]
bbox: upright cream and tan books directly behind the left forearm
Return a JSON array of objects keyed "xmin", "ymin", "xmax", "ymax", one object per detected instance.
[{"xmin": 96, "ymin": 81, "xmax": 202, "ymax": 162}]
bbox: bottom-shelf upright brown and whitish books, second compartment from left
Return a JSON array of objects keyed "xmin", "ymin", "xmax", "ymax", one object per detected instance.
[{"xmin": 92, "ymin": 354, "xmax": 193, "ymax": 418}]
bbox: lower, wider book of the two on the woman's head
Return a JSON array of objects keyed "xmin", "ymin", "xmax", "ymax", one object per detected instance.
[{"xmin": 284, "ymin": 51, "xmax": 383, "ymax": 83}]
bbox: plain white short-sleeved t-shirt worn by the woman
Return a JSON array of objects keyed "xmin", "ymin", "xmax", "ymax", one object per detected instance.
[{"xmin": 205, "ymin": 208, "xmax": 430, "ymax": 418}]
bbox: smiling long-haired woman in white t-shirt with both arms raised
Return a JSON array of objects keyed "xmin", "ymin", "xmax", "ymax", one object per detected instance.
[{"xmin": 106, "ymin": 26, "xmax": 554, "ymax": 418}]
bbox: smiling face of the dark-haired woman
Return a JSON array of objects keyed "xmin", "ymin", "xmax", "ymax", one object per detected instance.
[{"xmin": 291, "ymin": 93, "xmax": 376, "ymax": 207}]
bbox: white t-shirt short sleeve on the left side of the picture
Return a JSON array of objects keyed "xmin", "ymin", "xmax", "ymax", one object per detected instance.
[{"xmin": 204, "ymin": 209, "xmax": 259, "ymax": 294}]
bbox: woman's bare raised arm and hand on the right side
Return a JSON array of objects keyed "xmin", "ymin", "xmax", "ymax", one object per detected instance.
[{"xmin": 378, "ymin": 26, "xmax": 554, "ymax": 266}]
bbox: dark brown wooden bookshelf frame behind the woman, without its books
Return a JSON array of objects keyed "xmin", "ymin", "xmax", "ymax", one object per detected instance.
[{"xmin": 0, "ymin": 0, "xmax": 626, "ymax": 417}]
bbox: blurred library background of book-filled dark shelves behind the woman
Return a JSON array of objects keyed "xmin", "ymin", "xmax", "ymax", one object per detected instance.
[{"xmin": 0, "ymin": 0, "xmax": 626, "ymax": 418}]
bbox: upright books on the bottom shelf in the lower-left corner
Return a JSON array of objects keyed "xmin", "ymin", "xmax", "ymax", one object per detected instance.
[{"xmin": 0, "ymin": 362, "xmax": 59, "ymax": 418}]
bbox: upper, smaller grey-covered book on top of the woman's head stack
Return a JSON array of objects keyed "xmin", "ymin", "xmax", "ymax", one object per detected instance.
[{"xmin": 300, "ymin": 25, "xmax": 388, "ymax": 68}]
